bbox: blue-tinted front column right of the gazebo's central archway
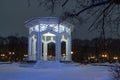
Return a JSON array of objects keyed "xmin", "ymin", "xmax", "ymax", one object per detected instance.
[{"xmin": 55, "ymin": 34, "xmax": 61, "ymax": 61}]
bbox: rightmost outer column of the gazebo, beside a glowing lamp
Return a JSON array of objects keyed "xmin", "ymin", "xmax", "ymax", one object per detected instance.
[{"xmin": 66, "ymin": 37, "xmax": 71, "ymax": 61}]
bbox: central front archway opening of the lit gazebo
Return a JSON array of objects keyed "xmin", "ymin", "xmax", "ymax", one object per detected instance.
[{"xmin": 42, "ymin": 32, "xmax": 56, "ymax": 61}]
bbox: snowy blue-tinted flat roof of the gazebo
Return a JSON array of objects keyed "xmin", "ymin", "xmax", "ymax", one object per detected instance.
[{"xmin": 24, "ymin": 17, "xmax": 73, "ymax": 31}]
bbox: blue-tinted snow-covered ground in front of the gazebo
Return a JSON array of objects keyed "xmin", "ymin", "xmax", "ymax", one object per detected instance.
[{"xmin": 0, "ymin": 63, "xmax": 112, "ymax": 80}]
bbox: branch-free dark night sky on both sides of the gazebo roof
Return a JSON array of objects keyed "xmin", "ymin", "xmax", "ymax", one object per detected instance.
[{"xmin": 0, "ymin": 0, "xmax": 114, "ymax": 39}]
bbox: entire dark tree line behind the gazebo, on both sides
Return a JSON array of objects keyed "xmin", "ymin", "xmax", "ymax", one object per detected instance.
[{"xmin": 0, "ymin": 36, "xmax": 120, "ymax": 63}]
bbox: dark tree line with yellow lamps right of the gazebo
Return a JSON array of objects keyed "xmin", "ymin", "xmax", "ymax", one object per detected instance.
[{"xmin": 72, "ymin": 38, "xmax": 120, "ymax": 63}]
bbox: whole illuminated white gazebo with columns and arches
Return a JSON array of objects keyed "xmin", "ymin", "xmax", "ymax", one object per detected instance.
[{"xmin": 25, "ymin": 17, "xmax": 72, "ymax": 61}]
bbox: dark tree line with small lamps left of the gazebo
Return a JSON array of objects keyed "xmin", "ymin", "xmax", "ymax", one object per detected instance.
[{"xmin": 0, "ymin": 36, "xmax": 28, "ymax": 61}]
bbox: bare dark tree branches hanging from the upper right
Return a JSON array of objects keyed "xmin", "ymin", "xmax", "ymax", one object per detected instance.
[{"xmin": 25, "ymin": 0, "xmax": 120, "ymax": 54}]
